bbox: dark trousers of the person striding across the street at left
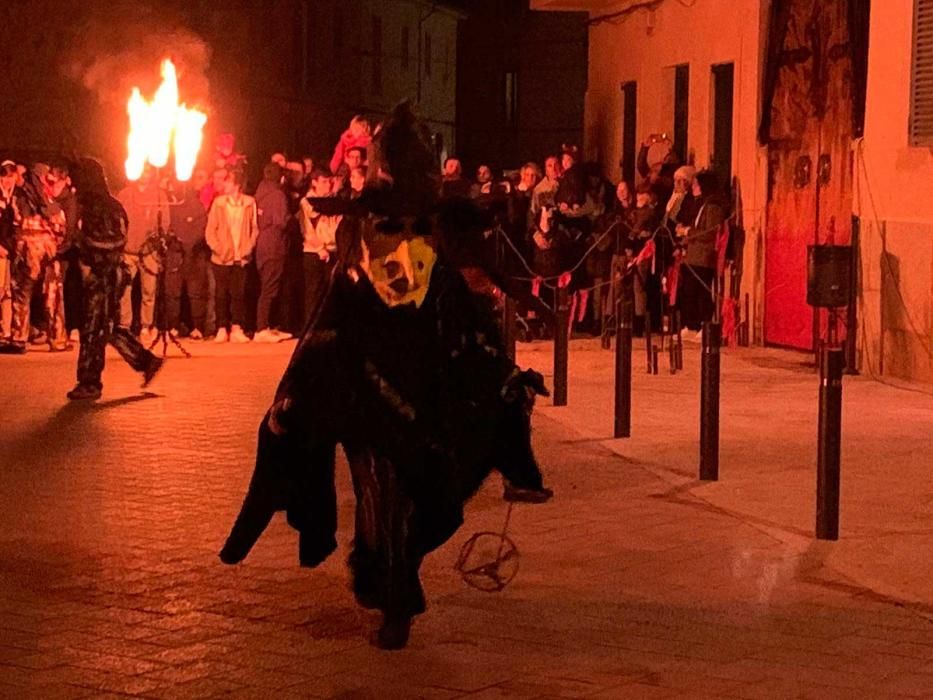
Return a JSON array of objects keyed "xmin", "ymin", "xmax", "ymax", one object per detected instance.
[{"xmin": 78, "ymin": 265, "xmax": 155, "ymax": 388}]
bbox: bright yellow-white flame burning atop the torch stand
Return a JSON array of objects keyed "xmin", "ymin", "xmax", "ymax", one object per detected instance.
[{"xmin": 124, "ymin": 59, "xmax": 207, "ymax": 182}]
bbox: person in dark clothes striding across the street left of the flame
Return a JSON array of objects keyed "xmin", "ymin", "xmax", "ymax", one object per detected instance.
[{"xmin": 68, "ymin": 158, "xmax": 163, "ymax": 401}]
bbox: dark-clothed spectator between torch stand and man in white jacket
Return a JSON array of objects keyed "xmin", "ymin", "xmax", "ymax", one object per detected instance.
[{"xmin": 165, "ymin": 183, "xmax": 210, "ymax": 340}]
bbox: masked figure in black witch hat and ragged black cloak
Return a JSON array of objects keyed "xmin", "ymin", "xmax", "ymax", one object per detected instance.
[{"xmin": 220, "ymin": 103, "xmax": 550, "ymax": 649}]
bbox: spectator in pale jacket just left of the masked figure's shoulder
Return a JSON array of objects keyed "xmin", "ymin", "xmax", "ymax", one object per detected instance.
[{"xmin": 300, "ymin": 170, "xmax": 343, "ymax": 319}]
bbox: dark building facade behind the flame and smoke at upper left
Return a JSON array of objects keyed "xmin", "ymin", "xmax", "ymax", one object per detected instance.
[{"xmin": 0, "ymin": 0, "xmax": 464, "ymax": 183}]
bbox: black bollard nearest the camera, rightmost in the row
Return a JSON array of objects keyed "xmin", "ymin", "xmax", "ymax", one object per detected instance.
[{"xmin": 816, "ymin": 347, "xmax": 846, "ymax": 540}]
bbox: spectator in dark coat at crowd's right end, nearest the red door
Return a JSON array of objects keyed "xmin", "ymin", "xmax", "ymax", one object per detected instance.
[{"xmin": 677, "ymin": 170, "xmax": 727, "ymax": 337}]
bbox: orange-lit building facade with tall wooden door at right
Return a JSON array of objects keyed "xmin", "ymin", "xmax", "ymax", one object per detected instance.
[{"xmin": 532, "ymin": 0, "xmax": 933, "ymax": 382}]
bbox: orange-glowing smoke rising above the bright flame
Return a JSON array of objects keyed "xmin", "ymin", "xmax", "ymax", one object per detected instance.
[{"xmin": 63, "ymin": 0, "xmax": 211, "ymax": 109}]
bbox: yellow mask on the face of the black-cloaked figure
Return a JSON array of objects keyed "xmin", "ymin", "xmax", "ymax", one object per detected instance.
[{"xmin": 360, "ymin": 217, "xmax": 437, "ymax": 308}]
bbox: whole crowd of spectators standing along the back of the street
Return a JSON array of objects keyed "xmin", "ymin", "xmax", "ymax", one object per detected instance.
[{"xmin": 0, "ymin": 117, "xmax": 729, "ymax": 354}]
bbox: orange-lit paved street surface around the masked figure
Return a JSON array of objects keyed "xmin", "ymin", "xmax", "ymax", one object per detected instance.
[{"xmin": 0, "ymin": 343, "xmax": 933, "ymax": 700}]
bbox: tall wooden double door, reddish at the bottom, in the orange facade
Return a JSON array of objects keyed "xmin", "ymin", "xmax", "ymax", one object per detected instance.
[{"xmin": 764, "ymin": 0, "xmax": 852, "ymax": 350}]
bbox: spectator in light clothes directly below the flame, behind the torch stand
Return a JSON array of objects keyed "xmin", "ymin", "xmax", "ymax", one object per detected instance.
[{"xmin": 117, "ymin": 170, "xmax": 170, "ymax": 345}]
